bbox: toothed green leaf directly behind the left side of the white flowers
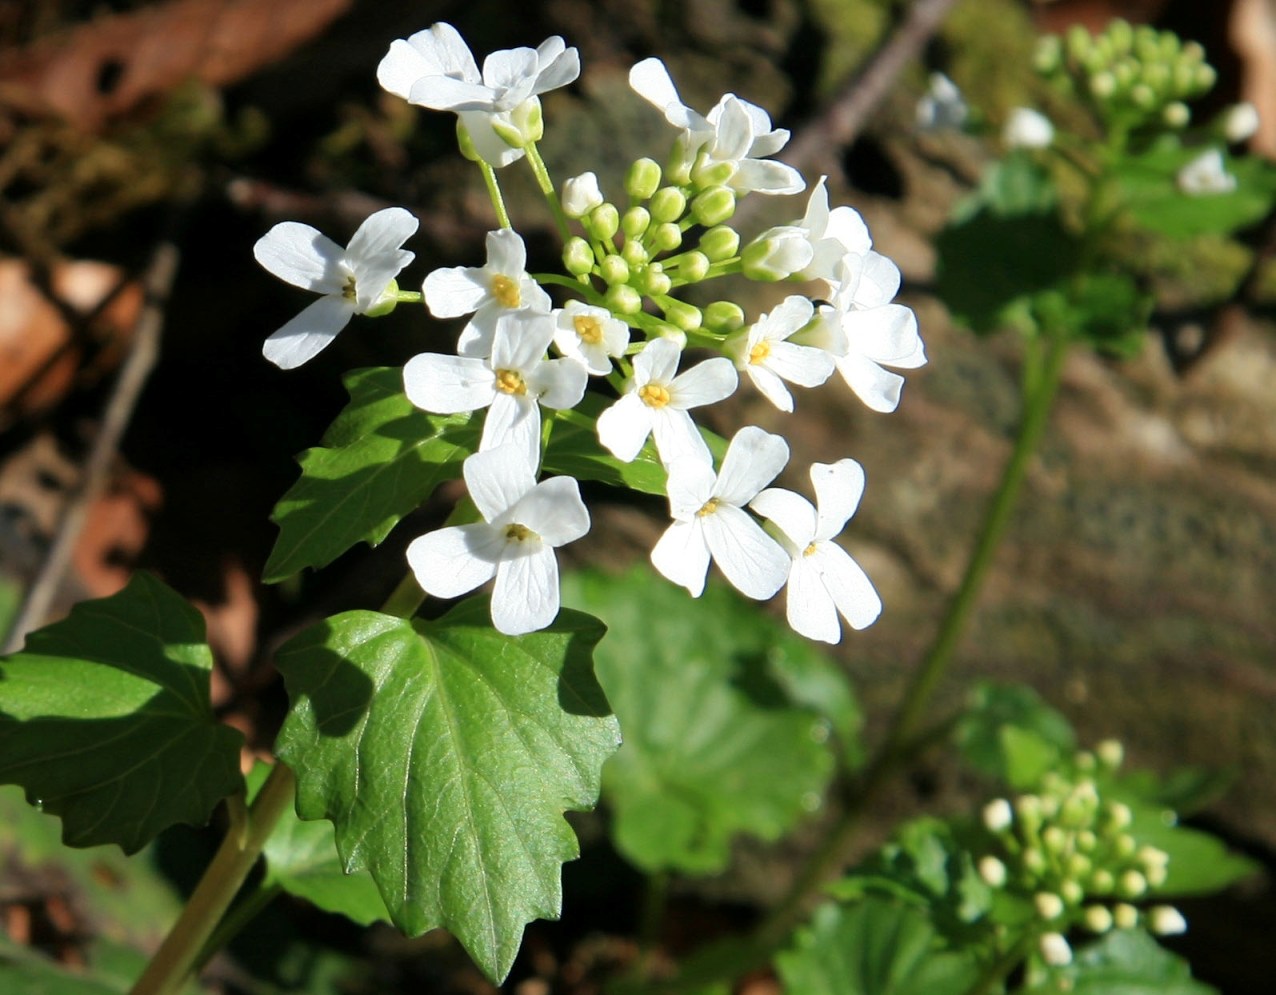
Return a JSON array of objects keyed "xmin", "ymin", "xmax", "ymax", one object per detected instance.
[{"xmin": 263, "ymin": 367, "xmax": 482, "ymax": 583}]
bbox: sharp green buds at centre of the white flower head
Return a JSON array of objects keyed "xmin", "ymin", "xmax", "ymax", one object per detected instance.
[{"xmin": 563, "ymin": 158, "xmax": 744, "ymax": 343}]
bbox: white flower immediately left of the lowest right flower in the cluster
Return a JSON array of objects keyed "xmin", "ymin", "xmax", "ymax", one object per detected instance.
[{"xmin": 651, "ymin": 425, "xmax": 789, "ymax": 601}]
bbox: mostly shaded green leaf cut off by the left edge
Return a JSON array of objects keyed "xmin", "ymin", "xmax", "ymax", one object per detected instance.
[{"xmin": 0, "ymin": 573, "xmax": 242, "ymax": 853}]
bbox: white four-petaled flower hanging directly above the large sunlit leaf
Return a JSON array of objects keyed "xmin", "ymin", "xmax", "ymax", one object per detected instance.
[{"xmin": 407, "ymin": 446, "xmax": 590, "ymax": 635}]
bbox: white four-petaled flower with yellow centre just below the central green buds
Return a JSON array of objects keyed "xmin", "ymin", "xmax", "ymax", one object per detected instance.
[{"xmin": 598, "ymin": 338, "xmax": 739, "ymax": 464}]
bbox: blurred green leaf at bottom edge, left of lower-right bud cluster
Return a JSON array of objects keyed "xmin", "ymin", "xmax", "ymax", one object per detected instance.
[{"xmin": 776, "ymin": 898, "xmax": 979, "ymax": 995}]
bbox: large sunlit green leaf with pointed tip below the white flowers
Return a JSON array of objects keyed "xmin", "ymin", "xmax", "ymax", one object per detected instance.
[{"xmin": 277, "ymin": 598, "xmax": 619, "ymax": 980}]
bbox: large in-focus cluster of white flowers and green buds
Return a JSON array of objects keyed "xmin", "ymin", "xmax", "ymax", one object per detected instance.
[{"xmin": 258, "ymin": 24, "xmax": 926, "ymax": 642}]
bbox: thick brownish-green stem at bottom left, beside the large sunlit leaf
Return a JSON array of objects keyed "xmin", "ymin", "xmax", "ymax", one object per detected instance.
[{"xmin": 129, "ymin": 763, "xmax": 295, "ymax": 995}]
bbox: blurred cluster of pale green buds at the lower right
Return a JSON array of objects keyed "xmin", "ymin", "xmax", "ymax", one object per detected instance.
[{"xmin": 977, "ymin": 740, "xmax": 1187, "ymax": 964}]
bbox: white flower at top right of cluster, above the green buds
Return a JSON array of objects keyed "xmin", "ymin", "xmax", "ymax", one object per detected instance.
[{"xmin": 629, "ymin": 59, "xmax": 806, "ymax": 194}]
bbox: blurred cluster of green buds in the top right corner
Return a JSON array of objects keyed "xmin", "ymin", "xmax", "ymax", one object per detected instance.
[{"xmin": 1035, "ymin": 20, "xmax": 1216, "ymax": 130}]
